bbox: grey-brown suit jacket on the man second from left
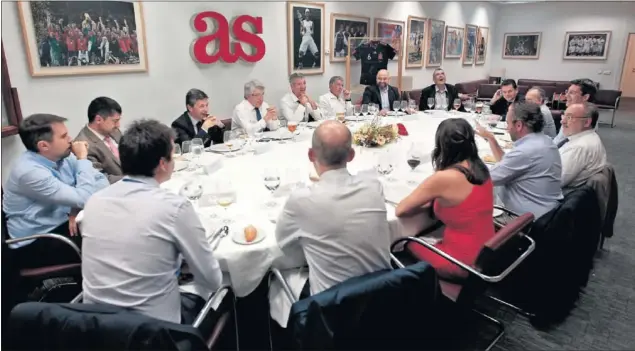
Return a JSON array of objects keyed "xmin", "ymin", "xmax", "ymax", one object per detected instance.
[{"xmin": 75, "ymin": 126, "xmax": 123, "ymax": 184}]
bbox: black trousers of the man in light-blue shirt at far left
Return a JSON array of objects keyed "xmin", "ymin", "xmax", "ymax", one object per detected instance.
[{"xmin": 12, "ymin": 222, "xmax": 82, "ymax": 268}]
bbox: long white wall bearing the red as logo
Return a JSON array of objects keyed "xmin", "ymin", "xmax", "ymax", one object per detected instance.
[{"xmin": 2, "ymin": 2, "xmax": 497, "ymax": 182}]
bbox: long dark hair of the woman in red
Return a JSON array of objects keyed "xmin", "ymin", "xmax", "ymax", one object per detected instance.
[{"xmin": 432, "ymin": 118, "xmax": 490, "ymax": 185}]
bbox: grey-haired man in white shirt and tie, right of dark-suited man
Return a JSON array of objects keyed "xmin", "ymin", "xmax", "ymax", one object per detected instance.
[{"xmin": 232, "ymin": 80, "xmax": 280, "ymax": 135}]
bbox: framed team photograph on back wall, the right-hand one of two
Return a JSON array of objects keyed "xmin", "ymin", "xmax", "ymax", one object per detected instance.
[{"xmin": 562, "ymin": 31, "xmax": 611, "ymax": 60}]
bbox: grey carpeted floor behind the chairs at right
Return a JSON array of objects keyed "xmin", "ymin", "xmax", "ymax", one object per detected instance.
[{"xmin": 494, "ymin": 99, "xmax": 635, "ymax": 350}]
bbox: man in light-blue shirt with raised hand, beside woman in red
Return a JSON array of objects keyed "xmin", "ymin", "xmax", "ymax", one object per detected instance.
[{"xmin": 476, "ymin": 102, "xmax": 562, "ymax": 218}]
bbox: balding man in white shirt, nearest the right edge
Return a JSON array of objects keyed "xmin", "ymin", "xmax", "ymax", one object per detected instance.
[{"xmin": 558, "ymin": 102, "xmax": 606, "ymax": 188}]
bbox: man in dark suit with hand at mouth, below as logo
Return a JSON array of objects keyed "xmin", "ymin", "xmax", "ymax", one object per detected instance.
[{"xmin": 172, "ymin": 89, "xmax": 225, "ymax": 147}]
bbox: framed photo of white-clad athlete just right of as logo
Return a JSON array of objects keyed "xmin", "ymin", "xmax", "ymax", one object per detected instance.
[{"xmin": 287, "ymin": 2, "xmax": 325, "ymax": 75}]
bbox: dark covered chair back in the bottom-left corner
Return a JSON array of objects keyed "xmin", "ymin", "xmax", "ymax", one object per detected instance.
[{"xmin": 3, "ymin": 302, "xmax": 207, "ymax": 350}]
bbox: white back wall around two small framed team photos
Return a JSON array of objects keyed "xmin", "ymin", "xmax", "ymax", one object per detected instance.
[{"xmin": 490, "ymin": 1, "xmax": 635, "ymax": 89}]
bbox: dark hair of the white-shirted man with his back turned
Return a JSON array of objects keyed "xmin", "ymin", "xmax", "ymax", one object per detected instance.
[{"xmin": 119, "ymin": 119, "xmax": 174, "ymax": 177}]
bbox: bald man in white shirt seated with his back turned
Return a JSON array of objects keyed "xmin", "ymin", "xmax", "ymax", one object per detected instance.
[{"xmin": 276, "ymin": 121, "xmax": 390, "ymax": 297}]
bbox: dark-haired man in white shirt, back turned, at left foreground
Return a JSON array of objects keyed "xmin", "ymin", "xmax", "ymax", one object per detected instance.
[{"xmin": 82, "ymin": 120, "xmax": 222, "ymax": 324}]
